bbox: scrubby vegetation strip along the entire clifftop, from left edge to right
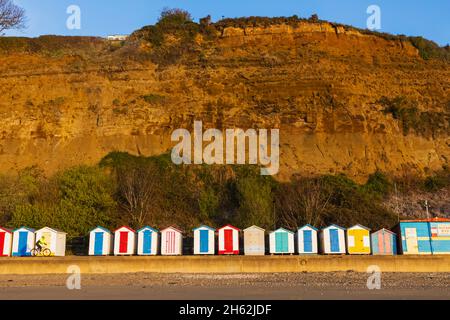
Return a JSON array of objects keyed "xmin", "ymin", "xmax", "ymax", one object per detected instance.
[{"xmin": 0, "ymin": 9, "xmax": 450, "ymax": 66}]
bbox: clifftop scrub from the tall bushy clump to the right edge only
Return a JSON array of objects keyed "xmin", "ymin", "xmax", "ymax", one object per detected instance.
[{"xmin": 131, "ymin": 9, "xmax": 450, "ymax": 65}]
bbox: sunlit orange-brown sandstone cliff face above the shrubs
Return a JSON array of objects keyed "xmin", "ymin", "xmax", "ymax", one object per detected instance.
[{"xmin": 0, "ymin": 23, "xmax": 450, "ymax": 180}]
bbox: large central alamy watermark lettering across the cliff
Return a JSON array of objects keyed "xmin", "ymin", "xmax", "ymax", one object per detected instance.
[{"xmin": 171, "ymin": 121, "xmax": 280, "ymax": 175}]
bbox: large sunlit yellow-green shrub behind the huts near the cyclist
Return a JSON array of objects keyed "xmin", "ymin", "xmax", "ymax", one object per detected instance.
[{"xmin": 9, "ymin": 166, "xmax": 116, "ymax": 236}]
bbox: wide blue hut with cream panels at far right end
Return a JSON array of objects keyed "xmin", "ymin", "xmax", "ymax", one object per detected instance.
[{"xmin": 395, "ymin": 218, "xmax": 450, "ymax": 254}]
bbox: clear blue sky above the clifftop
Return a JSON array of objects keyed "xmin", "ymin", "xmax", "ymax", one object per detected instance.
[{"xmin": 6, "ymin": 0, "xmax": 450, "ymax": 45}]
